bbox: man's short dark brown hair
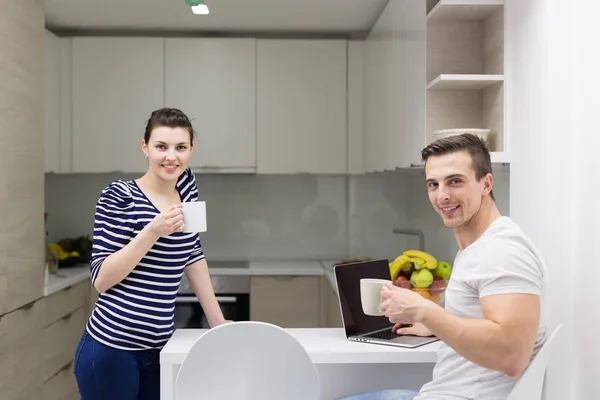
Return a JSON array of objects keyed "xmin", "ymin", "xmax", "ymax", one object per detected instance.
[{"xmin": 421, "ymin": 133, "xmax": 495, "ymax": 201}]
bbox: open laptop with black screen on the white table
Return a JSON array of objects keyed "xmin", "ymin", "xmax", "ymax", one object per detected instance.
[{"xmin": 333, "ymin": 259, "xmax": 439, "ymax": 348}]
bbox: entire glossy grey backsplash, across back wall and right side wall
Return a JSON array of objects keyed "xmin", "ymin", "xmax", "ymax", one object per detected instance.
[{"xmin": 45, "ymin": 170, "xmax": 509, "ymax": 261}]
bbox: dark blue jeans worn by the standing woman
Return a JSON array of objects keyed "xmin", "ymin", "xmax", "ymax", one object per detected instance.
[{"xmin": 74, "ymin": 332, "xmax": 160, "ymax": 400}]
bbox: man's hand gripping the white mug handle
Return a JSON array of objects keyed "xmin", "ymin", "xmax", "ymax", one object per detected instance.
[{"xmin": 379, "ymin": 283, "xmax": 435, "ymax": 324}]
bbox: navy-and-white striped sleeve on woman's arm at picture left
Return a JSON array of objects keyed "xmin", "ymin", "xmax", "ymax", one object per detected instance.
[{"xmin": 90, "ymin": 181, "xmax": 135, "ymax": 284}]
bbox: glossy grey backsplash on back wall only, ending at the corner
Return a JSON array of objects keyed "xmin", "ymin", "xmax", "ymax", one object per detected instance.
[{"xmin": 46, "ymin": 173, "xmax": 347, "ymax": 260}]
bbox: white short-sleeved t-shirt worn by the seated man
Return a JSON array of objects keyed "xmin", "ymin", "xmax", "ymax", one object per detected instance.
[{"xmin": 414, "ymin": 217, "xmax": 548, "ymax": 400}]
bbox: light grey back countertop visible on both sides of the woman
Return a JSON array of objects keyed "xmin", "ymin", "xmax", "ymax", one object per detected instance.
[{"xmin": 44, "ymin": 260, "xmax": 337, "ymax": 296}]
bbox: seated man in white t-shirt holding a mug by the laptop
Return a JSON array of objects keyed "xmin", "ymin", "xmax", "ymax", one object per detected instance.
[{"xmin": 344, "ymin": 134, "xmax": 547, "ymax": 400}]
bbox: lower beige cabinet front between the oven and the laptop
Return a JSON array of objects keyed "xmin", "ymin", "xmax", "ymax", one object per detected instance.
[{"xmin": 250, "ymin": 276, "xmax": 321, "ymax": 328}]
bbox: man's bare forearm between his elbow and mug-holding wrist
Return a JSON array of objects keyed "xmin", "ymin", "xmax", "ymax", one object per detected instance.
[{"xmin": 420, "ymin": 305, "xmax": 525, "ymax": 376}]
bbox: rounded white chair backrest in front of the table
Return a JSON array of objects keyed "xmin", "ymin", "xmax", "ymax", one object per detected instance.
[{"xmin": 175, "ymin": 321, "xmax": 321, "ymax": 400}]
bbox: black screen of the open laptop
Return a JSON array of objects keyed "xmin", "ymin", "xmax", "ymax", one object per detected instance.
[{"xmin": 335, "ymin": 259, "xmax": 392, "ymax": 336}]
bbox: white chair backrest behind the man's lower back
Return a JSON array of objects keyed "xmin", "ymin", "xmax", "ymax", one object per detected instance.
[{"xmin": 507, "ymin": 324, "xmax": 562, "ymax": 400}]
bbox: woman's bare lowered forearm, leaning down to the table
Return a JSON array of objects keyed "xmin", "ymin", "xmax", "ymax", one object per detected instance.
[{"xmin": 186, "ymin": 259, "xmax": 224, "ymax": 327}]
